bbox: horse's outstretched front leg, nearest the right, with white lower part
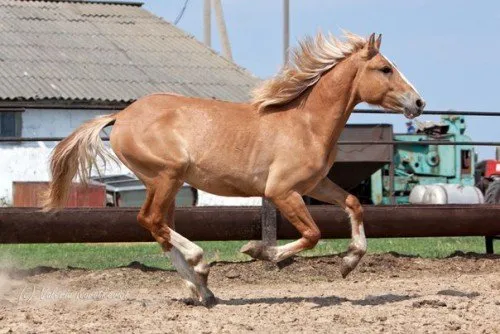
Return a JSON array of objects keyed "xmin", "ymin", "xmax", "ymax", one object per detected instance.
[{"xmin": 307, "ymin": 177, "xmax": 366, "ymax": 278}]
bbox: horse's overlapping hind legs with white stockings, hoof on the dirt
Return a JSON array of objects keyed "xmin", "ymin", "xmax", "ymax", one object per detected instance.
[{"xmin": 137, "ymin": 178, "xmax": 216, "ymax": 306}]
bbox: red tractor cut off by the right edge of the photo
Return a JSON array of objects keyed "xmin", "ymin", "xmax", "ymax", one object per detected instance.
[{"xmin": 476, "ymin": 160, "xmax": 500, "ymax": 204}]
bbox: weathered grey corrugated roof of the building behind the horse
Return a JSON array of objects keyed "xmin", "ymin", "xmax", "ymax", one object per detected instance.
[{"xmin": 0, "ymin": 0, "xmax": 258, "ymax": 103}]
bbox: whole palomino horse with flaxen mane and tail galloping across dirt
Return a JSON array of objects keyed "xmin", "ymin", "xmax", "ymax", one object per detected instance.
[{"xmin": 45, "ymin": 33, "xmax": 425, "ymax": 306}]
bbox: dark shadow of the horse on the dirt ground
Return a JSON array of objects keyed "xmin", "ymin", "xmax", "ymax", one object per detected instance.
[{"xmin": 218, "ymin": 294, "xmax": 419, "ymax": 308}]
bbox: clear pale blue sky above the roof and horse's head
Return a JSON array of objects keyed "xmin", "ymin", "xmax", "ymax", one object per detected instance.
[{"xmin": 143, "ymin": 0, "xmax": 500, "ymax": 158}]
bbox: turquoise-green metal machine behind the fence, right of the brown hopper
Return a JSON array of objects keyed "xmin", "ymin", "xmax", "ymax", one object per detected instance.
[{"xmin": 370, "ymin": 116, "xmax": 480, "ymax": 204}]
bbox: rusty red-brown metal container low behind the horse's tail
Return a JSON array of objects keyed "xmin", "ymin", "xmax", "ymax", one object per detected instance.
[{"xmin": 12, "ymin": 181, "xmax": 106, "ymax": 208}]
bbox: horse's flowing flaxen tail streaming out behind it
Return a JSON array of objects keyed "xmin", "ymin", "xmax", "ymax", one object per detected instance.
[{"xmin": 43, "ymin": 114, "xmax": 117, "ymax": 211}]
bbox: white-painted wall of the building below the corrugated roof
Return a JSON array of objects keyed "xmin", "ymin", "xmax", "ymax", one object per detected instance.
[{"xmin": 0, "ymin": 109, "xmax": 262, "ymax": 206}]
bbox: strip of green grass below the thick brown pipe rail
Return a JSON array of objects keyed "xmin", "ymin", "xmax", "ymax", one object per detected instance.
[{"xmin": 0, "ymin": 237, "xmax": 500, "ymax": 269}]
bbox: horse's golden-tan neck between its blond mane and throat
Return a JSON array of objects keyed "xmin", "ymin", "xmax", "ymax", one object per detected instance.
[{"xmin": 301, "ymin": 60, "xmax": 358, "ymax": 150}]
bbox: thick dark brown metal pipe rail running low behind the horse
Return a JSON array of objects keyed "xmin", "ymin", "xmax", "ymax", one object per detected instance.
[{"xmin": 0, "ymin": 205, "xmax": 500, "ymax": 243}]
